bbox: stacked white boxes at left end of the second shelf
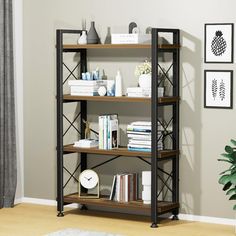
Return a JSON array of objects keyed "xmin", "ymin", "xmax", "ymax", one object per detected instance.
[{"xmin": 68, "ymin": 79, "xmax": 106, "ymax": 96}]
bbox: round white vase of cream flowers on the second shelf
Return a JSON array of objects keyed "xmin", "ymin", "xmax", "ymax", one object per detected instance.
[{"xmin": 135, "ymin": 60, "xmax": 152, "ymax": 88}]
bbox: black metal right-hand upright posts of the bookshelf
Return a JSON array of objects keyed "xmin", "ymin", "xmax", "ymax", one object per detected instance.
[{"xmin": 151, "ymin": 28, "xmax": 180, "ymax": 228}]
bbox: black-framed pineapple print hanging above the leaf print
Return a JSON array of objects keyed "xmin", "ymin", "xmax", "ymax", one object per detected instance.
[{"xmin": 204, "ymin": 23, "xmax": 234, "ymax": 63}]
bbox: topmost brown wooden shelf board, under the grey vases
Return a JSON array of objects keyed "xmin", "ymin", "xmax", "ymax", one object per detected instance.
[{"xmin": 63, "ymin": 44, "xmax": 180, "ymax": 50}]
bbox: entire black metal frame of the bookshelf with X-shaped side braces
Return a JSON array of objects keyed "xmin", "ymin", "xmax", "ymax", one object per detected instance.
[{"xmin": 57, "ymin": 28, "xmax": 180, "ymax": 228}]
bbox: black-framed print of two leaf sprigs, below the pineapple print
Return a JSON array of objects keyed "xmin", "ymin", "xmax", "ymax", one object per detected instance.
[{"xmin": 204, "ymin": 70, "xmax": 233, "ymax": 109}]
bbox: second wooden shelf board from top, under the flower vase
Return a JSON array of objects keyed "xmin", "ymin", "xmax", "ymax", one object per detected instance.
[{"xmin": 63, "ymin": 94, "xmax": 180, "ymax": 104}]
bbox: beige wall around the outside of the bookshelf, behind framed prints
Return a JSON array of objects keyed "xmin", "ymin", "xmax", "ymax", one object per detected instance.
[{"xmin": 23, "ymin": 0, "xmax": 236, "ymax": 218}]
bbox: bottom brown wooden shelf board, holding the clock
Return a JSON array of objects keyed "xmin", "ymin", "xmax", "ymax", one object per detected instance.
[{"xmin": 64, "ymin": 193, "xmax": 179, "ymax": 214}]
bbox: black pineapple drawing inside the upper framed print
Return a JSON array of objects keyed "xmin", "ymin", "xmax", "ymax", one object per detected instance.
[{"xmin": 211, "ymin": 30, "xmax": 227, "ymax": 56}]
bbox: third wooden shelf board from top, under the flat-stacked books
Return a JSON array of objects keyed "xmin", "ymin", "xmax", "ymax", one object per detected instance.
[{"xmin": 64, "ymin": 144, "xmax": 179, "ymax": 158}]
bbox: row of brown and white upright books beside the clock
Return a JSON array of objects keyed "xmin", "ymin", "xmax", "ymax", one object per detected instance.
[{"xmin": 110, "ymin": 173, "xmax": 138, "ymax": 202}]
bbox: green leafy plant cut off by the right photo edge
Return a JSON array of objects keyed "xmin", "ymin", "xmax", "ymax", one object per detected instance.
[{"xmin": 218, "ymin": 139, "xmax": 236, "ymax": 210}]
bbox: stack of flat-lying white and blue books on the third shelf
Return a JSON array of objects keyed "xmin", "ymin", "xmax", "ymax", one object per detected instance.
[{"xmin": 127, "ymin": 121, "xmax": 163, "ymax": 152}]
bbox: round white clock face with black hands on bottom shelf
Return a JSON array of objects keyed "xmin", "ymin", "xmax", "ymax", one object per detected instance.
[{"xmin": 79, "ymin": 170, "xmax": 98, "ymax": 189}]
